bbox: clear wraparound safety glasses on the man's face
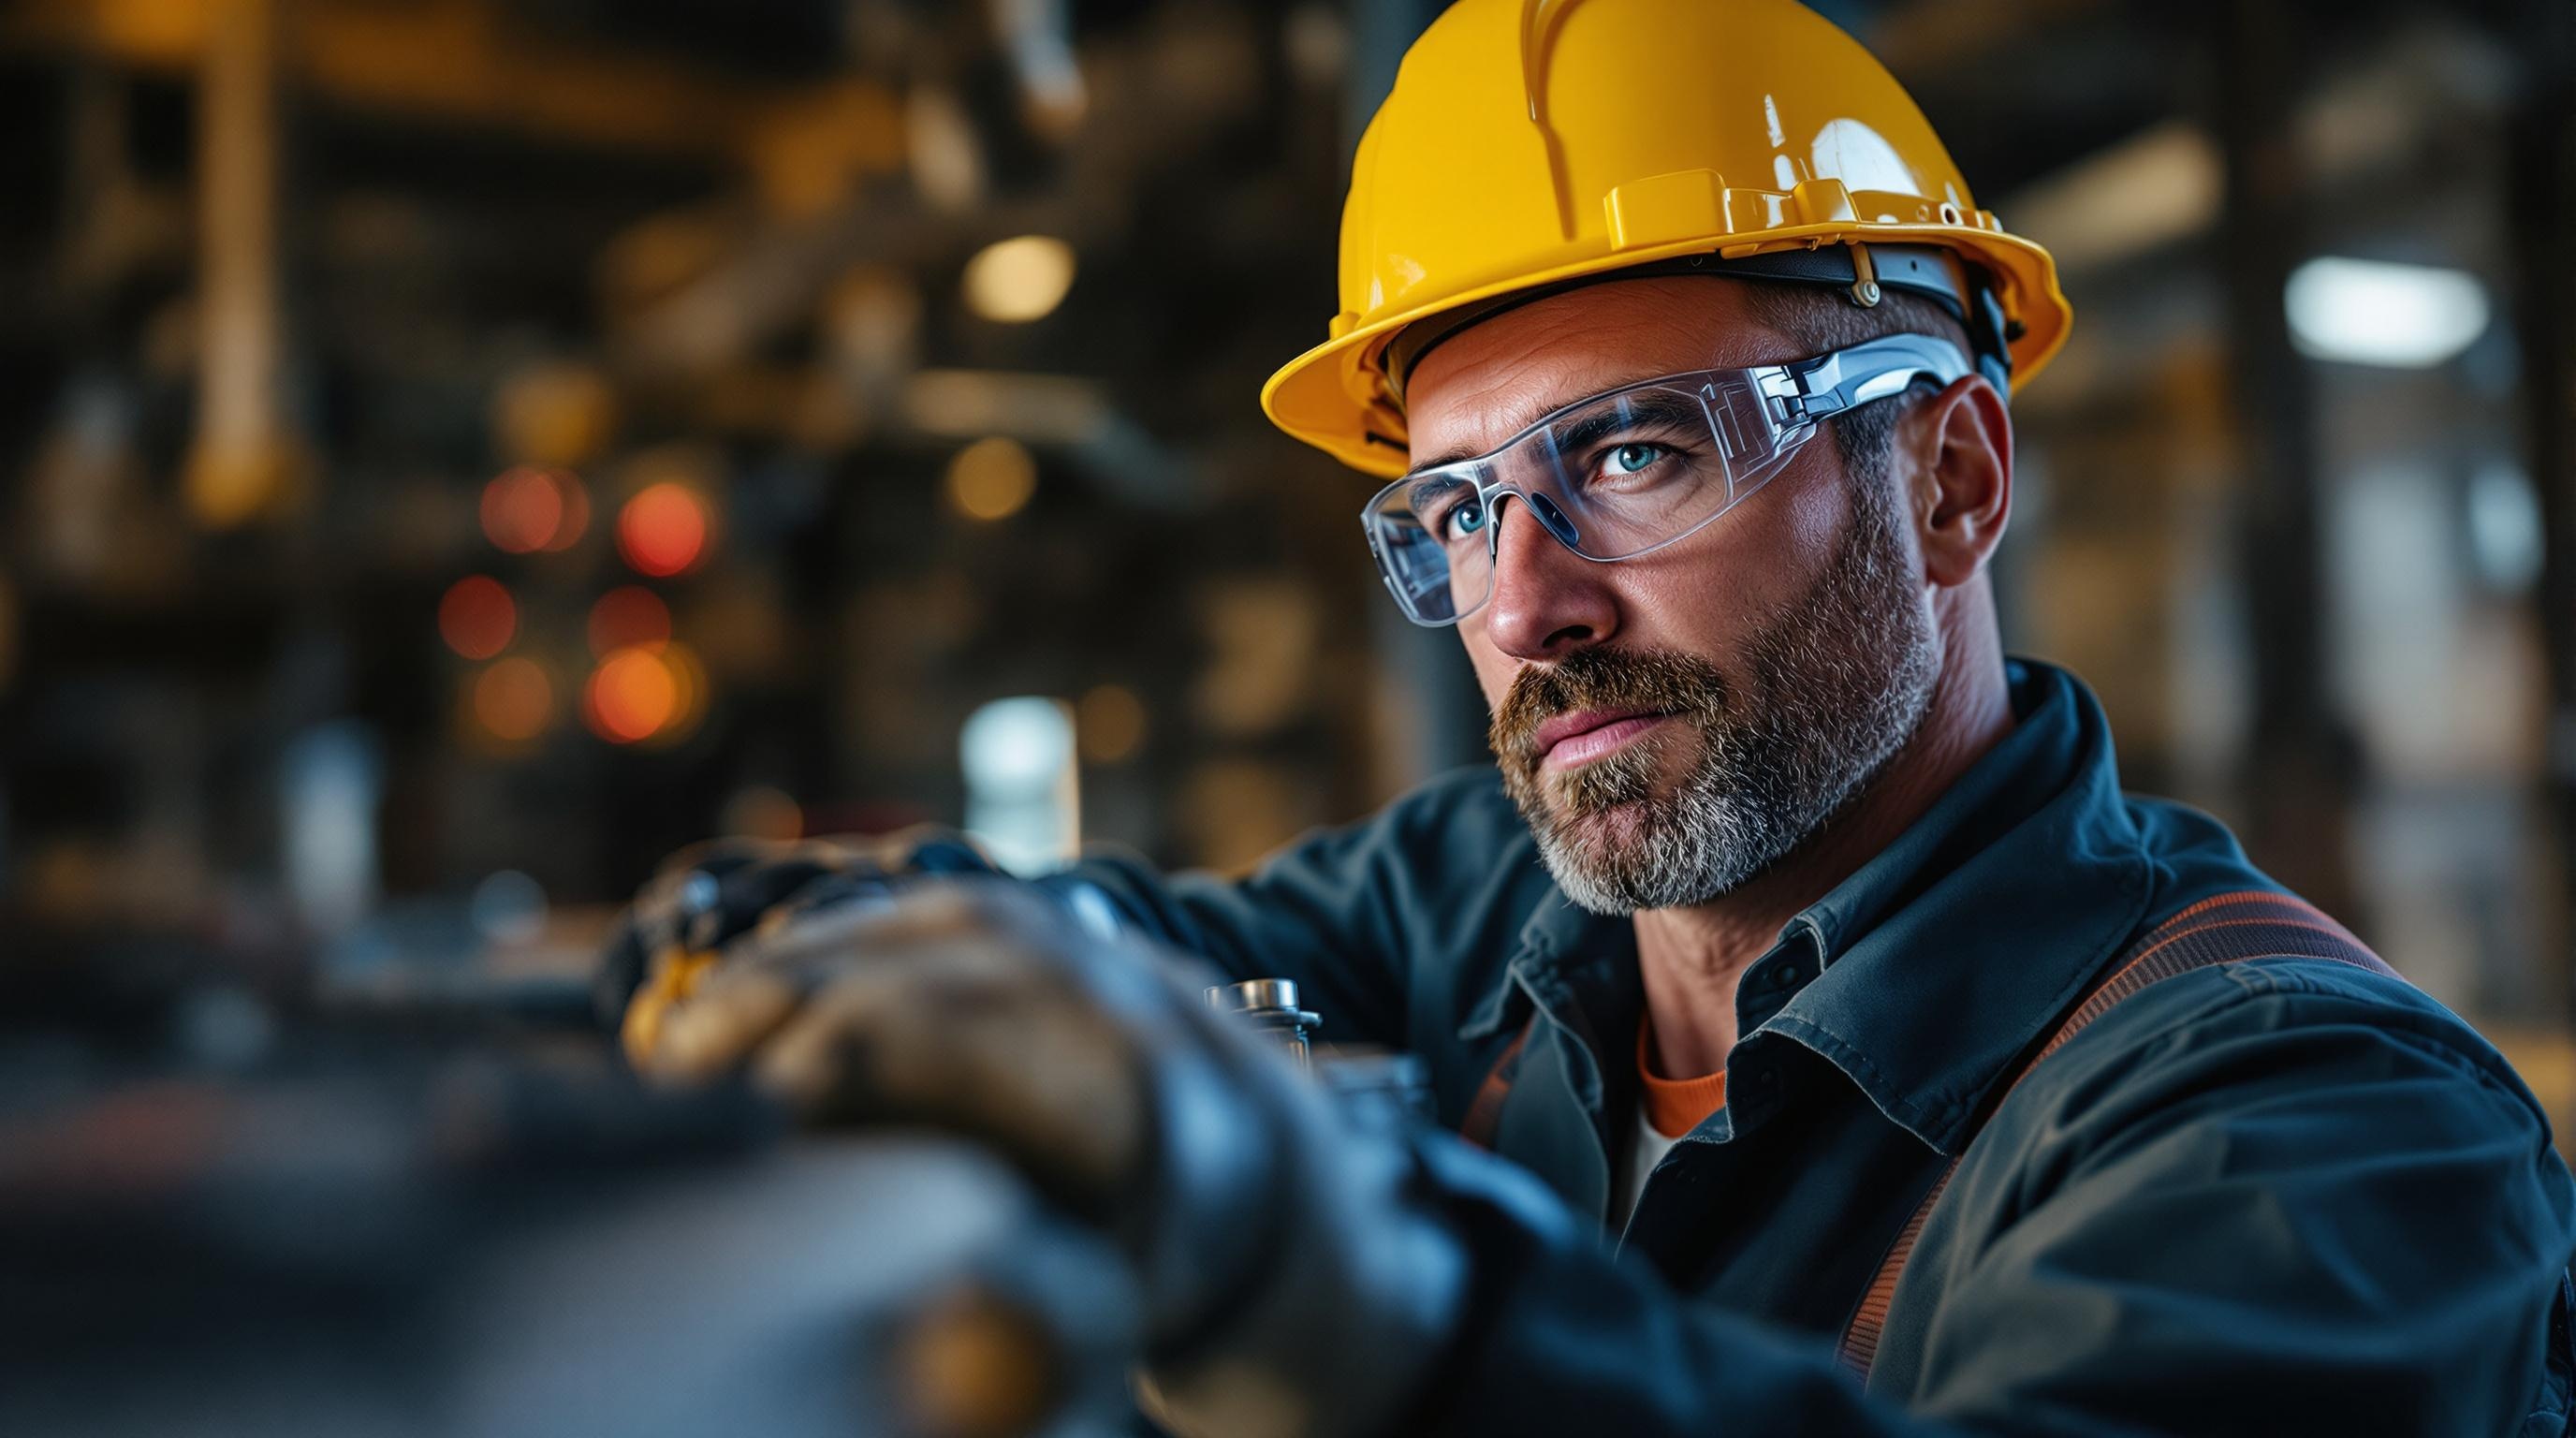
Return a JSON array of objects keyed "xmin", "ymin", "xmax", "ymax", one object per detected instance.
[{"xmin": 1360, "ymin": 335, "xmax": 1969, "ymax": 626}]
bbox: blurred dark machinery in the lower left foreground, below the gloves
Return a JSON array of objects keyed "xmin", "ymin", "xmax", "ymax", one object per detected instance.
[{"xmin": 0, "ymin": 963, "xmax": 1134, "ymax": 1438}]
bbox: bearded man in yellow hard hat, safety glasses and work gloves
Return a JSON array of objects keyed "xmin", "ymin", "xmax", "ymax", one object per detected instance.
[{"xmin": 628, "ymin": 0, "xmax": 2576, "ymax": 1432}]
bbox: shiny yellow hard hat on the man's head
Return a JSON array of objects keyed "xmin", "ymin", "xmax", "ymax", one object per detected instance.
[{"xmin": 1262, "ymin": 0, "xmax": 2073, "ymax": 474}]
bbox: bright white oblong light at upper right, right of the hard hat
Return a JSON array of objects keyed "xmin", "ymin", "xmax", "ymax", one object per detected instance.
[{"xmin": 2282, "ymin": 256, "xmax": 2488, "ymax": 369}]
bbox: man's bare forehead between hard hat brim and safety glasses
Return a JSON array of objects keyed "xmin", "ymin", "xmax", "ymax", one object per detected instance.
[{"xmin": 1404, "ymin": 276, "xmax": 1791, "ymax": 469}]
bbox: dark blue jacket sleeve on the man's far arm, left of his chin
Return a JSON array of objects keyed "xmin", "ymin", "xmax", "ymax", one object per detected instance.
[{"xmin": 1054, "ymin": 768, "xmax": 1545, "ymax": 1049}]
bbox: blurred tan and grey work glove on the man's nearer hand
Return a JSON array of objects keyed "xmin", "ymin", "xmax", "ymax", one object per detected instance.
[{"xmin": 638, "ymin": 881, "xmax": 1466, "ymax": 1435}]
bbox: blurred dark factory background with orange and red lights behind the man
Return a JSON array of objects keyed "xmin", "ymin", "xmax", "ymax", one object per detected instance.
[{"xmin": 0, "ymin": 0, "xmax": 2576, "ymax": 1095}]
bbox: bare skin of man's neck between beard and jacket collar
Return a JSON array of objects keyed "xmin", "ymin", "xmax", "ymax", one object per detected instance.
[{"xmin": 1636, "ymin": 631, "xmax": 2012, "ymax": 1078}]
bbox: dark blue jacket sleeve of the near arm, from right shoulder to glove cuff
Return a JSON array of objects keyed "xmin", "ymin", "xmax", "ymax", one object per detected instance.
[{"xmin": 1425, "ymin": 964, "xmax": 2576, "ymax": 1438}]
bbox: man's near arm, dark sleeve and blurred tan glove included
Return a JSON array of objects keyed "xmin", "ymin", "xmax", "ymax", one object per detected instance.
[{"xmin": 644, "ymin": 884, "xmax": 2576, "ymax": 1438}]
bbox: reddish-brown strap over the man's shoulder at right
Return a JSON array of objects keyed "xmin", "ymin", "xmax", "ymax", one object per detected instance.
[{"xmin": 1837, "ymin": 889, "xmax": 2398, "ymax": 1381}]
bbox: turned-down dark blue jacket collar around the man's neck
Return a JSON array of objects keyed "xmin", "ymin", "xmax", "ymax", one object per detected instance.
[{"xmin": 1458, "ymin": 660, "xmax": 2151, "ymax": 1152}]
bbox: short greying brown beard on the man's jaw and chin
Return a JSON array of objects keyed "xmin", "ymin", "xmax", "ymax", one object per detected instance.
[{"xmin": 1512, "ymin": 503, "xmax": 1942, "ymax": 915}]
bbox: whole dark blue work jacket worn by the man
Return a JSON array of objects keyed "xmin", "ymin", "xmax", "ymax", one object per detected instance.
[{"xmin": 1079, "ymin": 660, "xmax": 2576, "ymax": 1432}]
